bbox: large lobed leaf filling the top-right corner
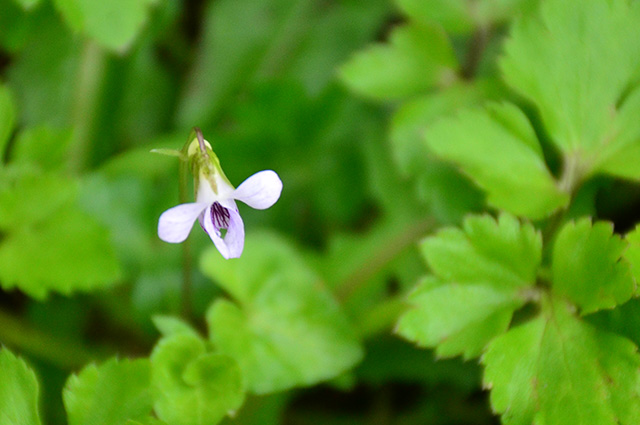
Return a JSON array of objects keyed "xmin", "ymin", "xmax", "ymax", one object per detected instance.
[{"xmin": 502, "ymin": 0, "xmax": 640, "ymax": 163}]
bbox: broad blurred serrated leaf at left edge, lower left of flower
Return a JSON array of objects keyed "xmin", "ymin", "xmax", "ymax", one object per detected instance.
[{"xmin": 0, "ymin": 208, "xmax": 120, "ymax": 299}]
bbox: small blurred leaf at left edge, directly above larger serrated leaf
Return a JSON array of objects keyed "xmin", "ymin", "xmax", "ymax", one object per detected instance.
[{"xmin": 0, "ymin": 166, "xmax": 78, "ymax": 230}]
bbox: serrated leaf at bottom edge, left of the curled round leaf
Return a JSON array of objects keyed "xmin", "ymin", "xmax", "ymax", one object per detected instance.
[{"xmin": 63, "ymin": 359, "xmax": 153, "ymax": 425}]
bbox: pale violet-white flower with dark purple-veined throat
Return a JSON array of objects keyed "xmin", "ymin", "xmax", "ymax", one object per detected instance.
[{"xmin": 158, "ymin": 134, "xmax": 282, "ymax": 259}]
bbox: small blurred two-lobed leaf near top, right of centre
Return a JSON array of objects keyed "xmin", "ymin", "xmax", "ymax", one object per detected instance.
[{"xmin": 340, "ymin": 24, "xmax": 457, "ymax": 100}]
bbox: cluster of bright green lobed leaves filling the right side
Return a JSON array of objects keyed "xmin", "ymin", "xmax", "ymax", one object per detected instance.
[{"xmin": 343, "ymin": 0, "xmax": 640, "ymax": 424}]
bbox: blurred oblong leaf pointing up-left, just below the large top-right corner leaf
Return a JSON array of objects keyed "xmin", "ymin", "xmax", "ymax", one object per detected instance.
[{"xmin": 426, "ymin": 103, "xmax": 569, "ymax": 219}]
